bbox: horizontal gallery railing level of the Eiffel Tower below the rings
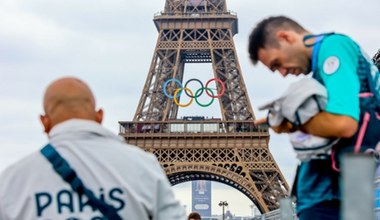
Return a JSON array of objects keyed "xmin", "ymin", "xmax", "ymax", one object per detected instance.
[{"xmin": 119, "ymin": 119, "xmax": 268, "ymax": 136}]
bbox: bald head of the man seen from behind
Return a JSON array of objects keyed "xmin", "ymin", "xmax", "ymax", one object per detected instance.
[{"xmin": 41, "ymin": 77, "xmax": 103, "ymax": 133}]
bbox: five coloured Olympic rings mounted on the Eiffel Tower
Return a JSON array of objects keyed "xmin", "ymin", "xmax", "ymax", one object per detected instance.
[{"xmin": 162, "ymin": 78, "xmax": 226, "ymax": 107}]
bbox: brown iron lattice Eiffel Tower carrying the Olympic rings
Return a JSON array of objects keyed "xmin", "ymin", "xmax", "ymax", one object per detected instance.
[{"xmin": 119, "ymin": 0, "xmax": 289, "ymax": 213}]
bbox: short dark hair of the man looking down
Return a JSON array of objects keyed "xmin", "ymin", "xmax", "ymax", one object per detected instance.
[{"xmin": 248, "ymin": 16, "xmax": 306, "ymax": 64}]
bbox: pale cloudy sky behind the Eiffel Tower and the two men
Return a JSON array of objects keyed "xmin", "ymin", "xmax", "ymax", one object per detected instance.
[{"xmin": 0, "ymin": 0, "xmax": 380, "ymax": 215}]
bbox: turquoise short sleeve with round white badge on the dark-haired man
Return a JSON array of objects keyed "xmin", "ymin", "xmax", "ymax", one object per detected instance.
[{"xmin": 318, "ymin": 35, "xmax": 360, "ymax": 121}]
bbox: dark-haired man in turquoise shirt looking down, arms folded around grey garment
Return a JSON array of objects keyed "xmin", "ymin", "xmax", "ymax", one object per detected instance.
[{"xmin": 249, "ymin": 16, "xmax": 380, "ymax": 220}]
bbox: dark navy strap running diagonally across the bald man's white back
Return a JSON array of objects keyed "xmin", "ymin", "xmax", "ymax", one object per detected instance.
[{"xmin": 40, "ymin": 144, "xmax": 122, "ymax": 220}]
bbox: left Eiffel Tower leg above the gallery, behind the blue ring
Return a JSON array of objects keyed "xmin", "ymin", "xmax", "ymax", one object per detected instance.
[{"xmin": 133, "ymin": 30, "xmax": 184, "ymax": 121}]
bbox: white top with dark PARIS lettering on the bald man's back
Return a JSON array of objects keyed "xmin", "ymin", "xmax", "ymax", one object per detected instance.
[{"xmin": 0, "ymin": 119, "xmax": 186, "ymax": 220}]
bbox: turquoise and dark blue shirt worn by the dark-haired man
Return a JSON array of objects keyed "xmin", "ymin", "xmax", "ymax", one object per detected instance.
[{"xmin": 297, "ymin": 35, "xmax": 362, "ymax": 213}]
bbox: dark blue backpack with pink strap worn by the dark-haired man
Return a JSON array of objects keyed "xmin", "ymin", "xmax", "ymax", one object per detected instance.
[{"xmin": 313, "ymin": 34, "xmax": 380, "ymax": 172}]
